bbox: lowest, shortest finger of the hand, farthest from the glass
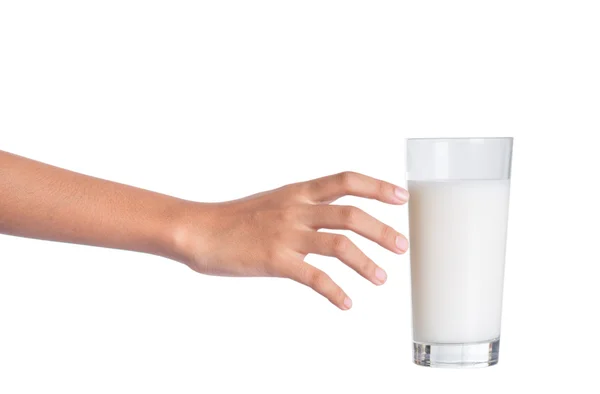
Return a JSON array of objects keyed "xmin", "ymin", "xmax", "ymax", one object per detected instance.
[{"xmin": 289, "ymin": 262, "xmax": 352, "ymax": 310}]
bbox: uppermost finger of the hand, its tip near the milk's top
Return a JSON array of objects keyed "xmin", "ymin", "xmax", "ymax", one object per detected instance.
[{"xmin": 307, "ymin": 171, "xmax": 409, "ymax": 204}]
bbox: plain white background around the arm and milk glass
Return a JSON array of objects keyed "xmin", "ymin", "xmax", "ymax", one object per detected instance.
[{"xmin": 0, "ymin": 0, "xmax": 600, "ymax": 394}]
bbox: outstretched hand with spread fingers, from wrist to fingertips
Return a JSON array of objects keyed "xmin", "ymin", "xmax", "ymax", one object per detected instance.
[{"xmin": 173, "ymin": 172, "xmax": 408, "ymax": 310}]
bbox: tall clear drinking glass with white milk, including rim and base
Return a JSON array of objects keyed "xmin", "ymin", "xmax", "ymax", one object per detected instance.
[{"xmin": 407, "ymin": 138, "xmax": 513, "ymax": 368}]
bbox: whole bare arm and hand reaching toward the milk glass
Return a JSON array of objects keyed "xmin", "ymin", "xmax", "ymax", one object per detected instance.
[{"xmin": 0, "ymin": 151, "xmax": 408, "ymax": 310}]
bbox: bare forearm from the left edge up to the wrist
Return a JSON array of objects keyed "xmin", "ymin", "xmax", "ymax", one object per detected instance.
[{"xmin": 0, "ymin": 151, "xmax": 185, "ymax": 258}]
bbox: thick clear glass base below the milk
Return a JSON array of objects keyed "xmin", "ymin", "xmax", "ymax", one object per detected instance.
[{"xmin": 413, "ymin": 338, "xmax": 500, "ymax": 368}]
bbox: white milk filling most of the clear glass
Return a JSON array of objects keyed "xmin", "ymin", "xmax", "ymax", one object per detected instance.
[{"xmin": 408, "ymin": 180, "xmax": 510, "ymax": 343}]
